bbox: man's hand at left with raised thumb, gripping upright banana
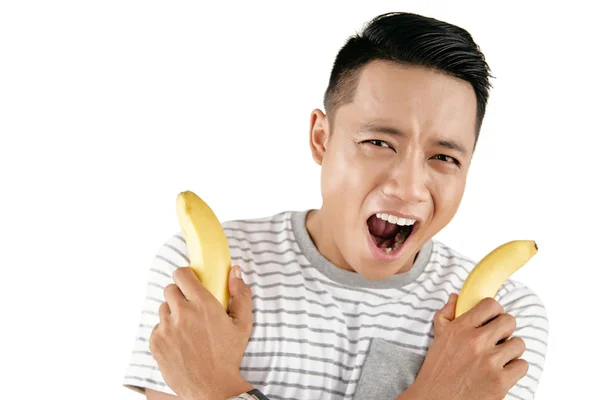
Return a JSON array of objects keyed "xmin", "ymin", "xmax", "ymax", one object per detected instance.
[{"xmin": 150, "ymin": 266, "xmax": 252, "ymax": 400}]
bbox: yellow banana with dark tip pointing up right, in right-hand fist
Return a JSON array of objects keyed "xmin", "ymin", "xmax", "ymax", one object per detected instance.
[{"xmin": 454, "ymin": 240, "xmax": 538, "ymax": 318}]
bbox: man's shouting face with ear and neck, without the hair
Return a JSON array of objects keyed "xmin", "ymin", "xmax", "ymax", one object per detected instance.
[{"xmin": 311, "ymin": 61, "xmax": 476, "ymax": 279}]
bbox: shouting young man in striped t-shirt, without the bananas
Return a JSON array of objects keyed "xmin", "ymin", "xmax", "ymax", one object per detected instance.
[{"xmin": 124, "ymin": 13, "xmax": 548, "ymax": 400}]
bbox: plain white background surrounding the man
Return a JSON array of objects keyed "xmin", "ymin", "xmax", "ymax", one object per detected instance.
[{"xmin": 0, "ymin": 0, "xmax": 600, "ymax": 400}]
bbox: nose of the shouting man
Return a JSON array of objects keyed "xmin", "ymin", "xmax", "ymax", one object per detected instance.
[{"xmin": 383, "ymin": 155, "xmax": 429, "ymax": 203}]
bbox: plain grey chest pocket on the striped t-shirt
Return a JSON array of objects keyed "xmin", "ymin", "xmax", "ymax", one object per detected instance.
[{"xmin": 353, "ymin": 338, "xmax": 425, "ymax": 400}]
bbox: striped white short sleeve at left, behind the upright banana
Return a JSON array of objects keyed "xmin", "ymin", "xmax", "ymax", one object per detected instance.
[{"xmin": 123, "ymin": 234, "xmax": 189, "ymax": 395}]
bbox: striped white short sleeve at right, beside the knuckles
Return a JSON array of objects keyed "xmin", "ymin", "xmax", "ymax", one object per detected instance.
[{"xmin": 496, "ymin": 280, "xmax": 549, "ymax": 400}]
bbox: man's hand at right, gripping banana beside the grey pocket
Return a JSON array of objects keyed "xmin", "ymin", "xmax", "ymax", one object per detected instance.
[{"xmin": 400, "ymin": 294, "xmax": 529, "ymax": 400}]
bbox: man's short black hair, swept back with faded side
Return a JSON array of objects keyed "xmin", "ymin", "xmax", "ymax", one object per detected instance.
[{"xmin": 324, "ymin": 12, "xmax": 491, "ymax": 139}]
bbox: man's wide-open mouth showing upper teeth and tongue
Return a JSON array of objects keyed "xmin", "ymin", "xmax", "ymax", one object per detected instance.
[{"xmin": 367, "ymin": 213, "xmax": 416, "ymax": 254}]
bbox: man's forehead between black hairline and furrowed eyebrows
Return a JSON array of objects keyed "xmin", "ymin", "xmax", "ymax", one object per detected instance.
[{"xmin": 338, "ymin": 60, "xmax": 477, "ymax": 147}]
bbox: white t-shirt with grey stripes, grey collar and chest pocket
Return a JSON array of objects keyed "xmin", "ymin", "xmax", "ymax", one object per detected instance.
[{"xmin": 124, "ymin": 211, "xmax": 548, "ymax": 400}]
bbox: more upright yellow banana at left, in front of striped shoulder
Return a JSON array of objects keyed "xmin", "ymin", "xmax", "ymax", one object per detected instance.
[{"xmin": 177, "ymin": 191, "xmax": 231, "ymax": 310}]
